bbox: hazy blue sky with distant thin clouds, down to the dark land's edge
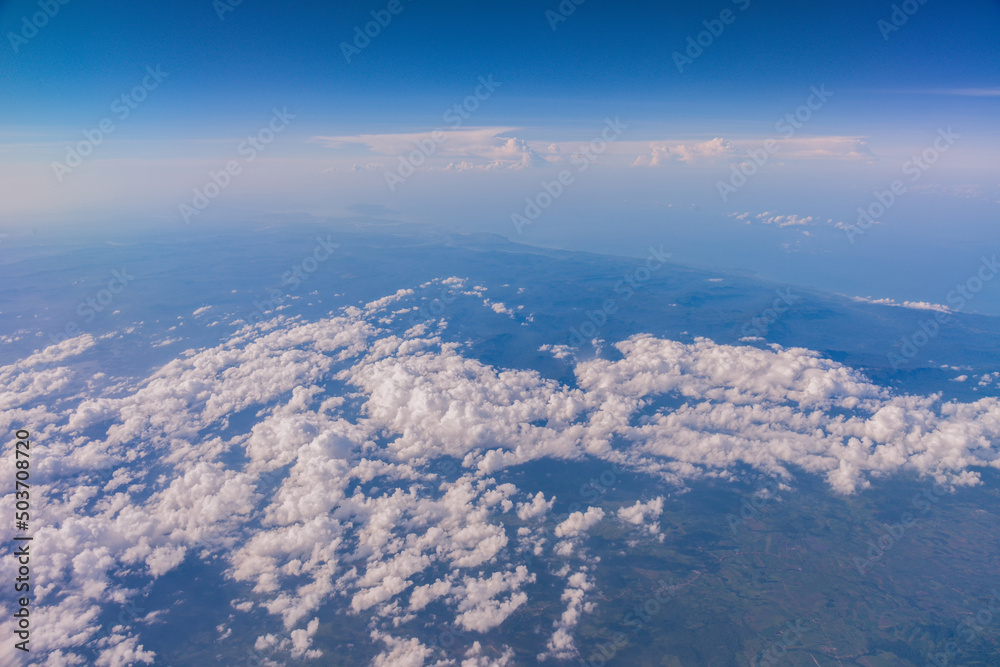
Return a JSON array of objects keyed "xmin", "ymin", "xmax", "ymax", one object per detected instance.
[{"xmin": 0, "ymin": 0, "xmax": 1000, "ymax": 312}]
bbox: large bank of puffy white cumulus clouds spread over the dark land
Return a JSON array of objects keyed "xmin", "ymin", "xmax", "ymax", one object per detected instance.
[{"xmin": 0, "ymin": 281, "xmax": 1000, "ymax": 665}]
